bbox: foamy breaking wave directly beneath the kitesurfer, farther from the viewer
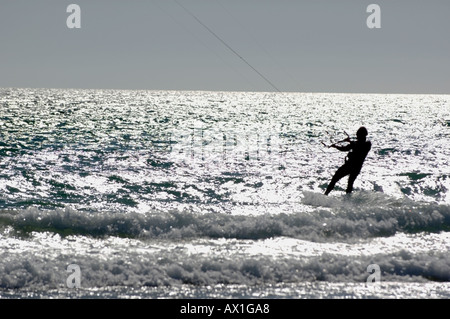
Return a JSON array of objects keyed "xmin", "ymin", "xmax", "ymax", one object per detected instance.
[{"xmin": 0, "ymin": 192, "xmax": 450, "ymax": 242}]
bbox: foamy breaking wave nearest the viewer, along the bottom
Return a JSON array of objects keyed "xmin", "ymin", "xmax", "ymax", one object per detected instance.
[{"xmin": 0, "ymin": 235, "xmax": 450, "ymax": 289}]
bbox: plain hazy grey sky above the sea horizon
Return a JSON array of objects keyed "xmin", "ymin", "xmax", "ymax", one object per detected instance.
[{"xmin": 0, "ymin": 0, "xmax": 450, "ymax": 94}]
